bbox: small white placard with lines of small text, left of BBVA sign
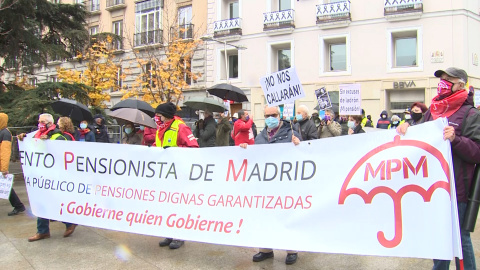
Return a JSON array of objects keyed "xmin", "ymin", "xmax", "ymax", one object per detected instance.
[{"xmin": 338, "ymin": 84, "xmax": 362, "ymax": 115}]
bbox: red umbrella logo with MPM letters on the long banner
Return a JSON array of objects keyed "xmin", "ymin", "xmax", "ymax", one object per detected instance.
[{"xmin": 338, "ymin": 135, "xmax": 450, "ymax": 248}]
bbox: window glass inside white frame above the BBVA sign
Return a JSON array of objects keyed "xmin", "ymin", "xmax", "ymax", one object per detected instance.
[{"xmin": 394, "ymin": 37, "xmax": 417, "ymax": 67}]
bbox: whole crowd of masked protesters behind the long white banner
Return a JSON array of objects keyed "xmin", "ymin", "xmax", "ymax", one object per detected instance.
[{"xmin": 4, "ymin": 68, "xmax": 480, "ymax": 269}]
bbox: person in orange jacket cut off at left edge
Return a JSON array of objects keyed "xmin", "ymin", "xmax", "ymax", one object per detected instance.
[{"xmin": 0, "ymin": 113, "xmax": 25, "ymax": 216}]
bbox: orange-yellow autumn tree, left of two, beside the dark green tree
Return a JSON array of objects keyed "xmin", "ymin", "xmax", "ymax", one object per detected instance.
[{"xmin": 57, "ymin": 35, "xmax": 124, "ymax": 108}]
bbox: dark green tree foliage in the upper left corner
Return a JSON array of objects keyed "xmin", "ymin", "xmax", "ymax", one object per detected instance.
[{"xmin": 0, "ymin": 0, "xmax": 88, "ymax": 80}]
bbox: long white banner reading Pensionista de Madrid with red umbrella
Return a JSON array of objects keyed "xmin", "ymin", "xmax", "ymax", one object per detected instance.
[{"xmin": 20, "ymin": 119, "xmax": 459, "ymax": 259}]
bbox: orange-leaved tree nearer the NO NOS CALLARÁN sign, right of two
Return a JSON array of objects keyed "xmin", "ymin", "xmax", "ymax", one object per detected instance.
[{"xmin": 122, "ymin": 24, "xmax": 201, "ymax": 108}]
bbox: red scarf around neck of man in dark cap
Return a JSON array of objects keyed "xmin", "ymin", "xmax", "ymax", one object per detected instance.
[{"xmin": 430, "ymin": 90, "xmax": 468, "ymax": 120}]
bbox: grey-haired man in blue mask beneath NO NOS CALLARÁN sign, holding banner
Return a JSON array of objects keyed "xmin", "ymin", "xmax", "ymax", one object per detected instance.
[{"xmin": 240, "ymin": 106, "xmax": 300, "ymax": 264}]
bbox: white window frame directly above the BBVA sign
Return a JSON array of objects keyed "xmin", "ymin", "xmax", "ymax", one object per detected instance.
[{"xmin": 386, "ymin": 26, "xmax": 423, "ymax": 73}]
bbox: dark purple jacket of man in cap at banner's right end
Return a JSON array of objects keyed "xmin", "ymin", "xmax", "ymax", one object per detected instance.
[{"xmin": 424, "ymin": 92, "xmax": 480, "ymax": 202}]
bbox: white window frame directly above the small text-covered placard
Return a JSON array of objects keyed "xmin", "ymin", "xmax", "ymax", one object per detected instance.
[{"xmin": 318, "ymin": 33, "xmax": 352, "ymax": 77}]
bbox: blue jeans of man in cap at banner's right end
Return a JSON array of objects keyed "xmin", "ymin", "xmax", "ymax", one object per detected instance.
[{"xmin": 433, "ymin": 202, "xmax": 477, "ymax": 270}]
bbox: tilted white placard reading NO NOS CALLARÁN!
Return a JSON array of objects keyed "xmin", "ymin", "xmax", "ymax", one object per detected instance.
[{"xmin": 260, "ymin": 67, "xmax": 305, "ymax": 107}]
